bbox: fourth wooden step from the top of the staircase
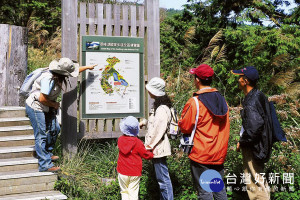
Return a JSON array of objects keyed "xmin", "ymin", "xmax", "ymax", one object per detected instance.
[{"xmin": 0, "ymin": 135, "xmax": 34, "ymax": 147}]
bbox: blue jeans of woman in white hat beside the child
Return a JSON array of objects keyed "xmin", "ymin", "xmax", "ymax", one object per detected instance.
[{"xmin": 152, "ymin": 157, "xmax": 173, "ymax": 200}]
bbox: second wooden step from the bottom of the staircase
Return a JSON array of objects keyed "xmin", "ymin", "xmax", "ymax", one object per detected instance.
[{"xmin": 0, "ymin": 169, "xmax": 57, "ymax": 196}]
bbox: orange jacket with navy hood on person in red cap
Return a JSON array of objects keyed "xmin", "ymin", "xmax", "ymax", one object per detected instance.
[{"xmin": 178, "ymin": 88, "xmax": 230, "ymax": 165}]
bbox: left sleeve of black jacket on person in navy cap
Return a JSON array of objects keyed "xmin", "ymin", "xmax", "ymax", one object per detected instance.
[{"xmin": 239, "ymin": 106, "xmax": 264, "ymax": 146}]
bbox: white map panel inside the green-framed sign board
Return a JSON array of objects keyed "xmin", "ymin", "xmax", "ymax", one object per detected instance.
[{"xmin": 85, "ymin": 52, "xmax": 141, "ymax": 114}]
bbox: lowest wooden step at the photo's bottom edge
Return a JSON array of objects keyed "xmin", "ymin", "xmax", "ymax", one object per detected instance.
[{"xmin": 0, "ymin": 191, "xmax": 68, "ymax": 200}]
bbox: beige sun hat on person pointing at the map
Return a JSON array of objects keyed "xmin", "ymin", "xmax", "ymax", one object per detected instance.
[{"xmin": 49, "ymin": 58, "xmax": 79, "ymax": 77}]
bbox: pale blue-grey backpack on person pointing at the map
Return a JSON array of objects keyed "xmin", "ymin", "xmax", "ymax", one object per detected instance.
[{"xmin": 19, "ymin": 67, "xmax": 49, "ymax": 98}]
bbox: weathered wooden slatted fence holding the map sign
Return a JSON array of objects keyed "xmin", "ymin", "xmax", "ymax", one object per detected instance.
[{"xmin": 62, "ymin": 0, "xmax": 160, "ymax": 153}]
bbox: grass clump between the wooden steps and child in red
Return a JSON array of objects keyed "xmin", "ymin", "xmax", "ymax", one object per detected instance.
[{"xmin": 56, "ymin": 141, "xmax": 120, "ymax": 200}]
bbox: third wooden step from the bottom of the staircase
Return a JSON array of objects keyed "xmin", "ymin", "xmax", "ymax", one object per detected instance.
[{"xmin": 0, "ymin": 157, "xmax": 38, "ymax": 172}]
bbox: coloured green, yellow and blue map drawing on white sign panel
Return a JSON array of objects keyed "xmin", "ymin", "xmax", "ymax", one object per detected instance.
[{"xmin": 100, "ymin": 56, "xmax": 129, "ymax": 94}]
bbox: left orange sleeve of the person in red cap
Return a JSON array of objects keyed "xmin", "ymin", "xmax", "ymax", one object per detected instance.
[{"xmin": 178, "ymin": 98, "xmax": 197, "ymax": 134}]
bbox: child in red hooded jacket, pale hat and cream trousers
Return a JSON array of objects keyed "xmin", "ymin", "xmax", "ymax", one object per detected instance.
[{"xmin": 117, "ymin": 116, "xmax": 153, "ymax": 200}]
